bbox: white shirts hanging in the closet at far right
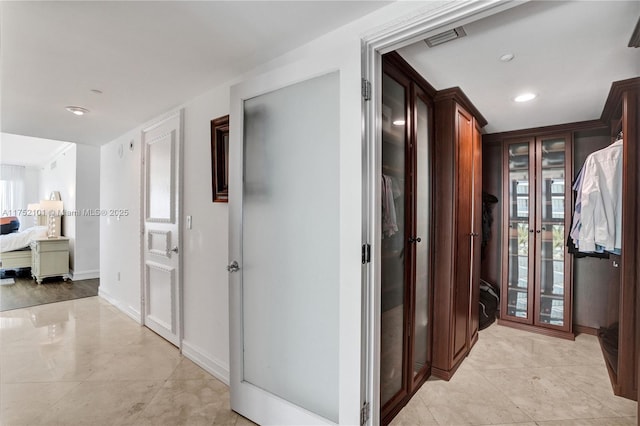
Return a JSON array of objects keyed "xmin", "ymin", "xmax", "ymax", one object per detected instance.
[{"xmin": 572, "ymin": 139, "xmax": 622, "ymax": 254}]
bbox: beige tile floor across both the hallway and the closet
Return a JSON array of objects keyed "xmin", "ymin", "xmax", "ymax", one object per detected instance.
[{"xmin": 0, "ymin": 297, "xmax": 636, "ymax": 426}]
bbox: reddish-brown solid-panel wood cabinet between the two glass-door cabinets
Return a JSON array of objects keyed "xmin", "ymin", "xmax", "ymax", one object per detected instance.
[{"xmin": 432, "ymin": 88, "xmax": 486, "ymax": 380}]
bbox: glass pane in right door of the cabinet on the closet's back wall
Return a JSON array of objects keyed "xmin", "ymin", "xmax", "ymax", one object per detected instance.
[{"xmin": 540, "ymin": 139, "xmax": 566, "ymax": 326}]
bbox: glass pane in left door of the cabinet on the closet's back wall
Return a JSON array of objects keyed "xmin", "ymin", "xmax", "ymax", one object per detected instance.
[{"xmin": 507, "ymin": 143, "xmax": 531, "ymax": 318}]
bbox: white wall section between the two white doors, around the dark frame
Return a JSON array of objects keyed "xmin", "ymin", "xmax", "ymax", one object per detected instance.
[{"xmin": 182, "ymin": 87, "xmax": 229, "ymax": 382}]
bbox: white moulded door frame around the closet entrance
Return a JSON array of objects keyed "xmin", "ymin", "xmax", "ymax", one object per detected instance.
[{"xmin": 361, "ymin": 0, "xmax": 529, "ymax": 425}]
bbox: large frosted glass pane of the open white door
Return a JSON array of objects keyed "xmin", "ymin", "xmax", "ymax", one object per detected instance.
[{"xmin": 241, "ymin": 72, "xmax": 340, "ymax": 422}]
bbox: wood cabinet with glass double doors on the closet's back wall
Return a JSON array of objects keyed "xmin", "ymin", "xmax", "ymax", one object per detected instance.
[{"xmin": 499, "ymin": 133, "xmax": 573, "ymax": 339}]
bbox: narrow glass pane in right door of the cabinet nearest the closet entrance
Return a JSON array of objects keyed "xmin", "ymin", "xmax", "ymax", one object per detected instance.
[{"xmin": 413, "ymin": 99, "xmax": 431, "ymax": 375}]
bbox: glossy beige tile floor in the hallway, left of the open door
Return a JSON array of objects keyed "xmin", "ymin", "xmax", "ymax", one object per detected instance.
[{"xmin": 0, "ymin": 297, "xmax": 253, "ymax": 426}]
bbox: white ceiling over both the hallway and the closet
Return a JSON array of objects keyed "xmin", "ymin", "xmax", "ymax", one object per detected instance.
[{"xmin": 0, "ymin": 1, "xmax": 640, "ymax": 150}]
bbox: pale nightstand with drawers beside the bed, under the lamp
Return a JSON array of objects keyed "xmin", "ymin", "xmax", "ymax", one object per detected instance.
[{"xmin": 31, "ymin": 237, "xmax": 69, "ymax": 284}]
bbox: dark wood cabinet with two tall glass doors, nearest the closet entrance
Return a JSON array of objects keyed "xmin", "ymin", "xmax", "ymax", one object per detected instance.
[{"xmin": 380, "ymin": 56, "xmax": 433, "ymax": 424}]
